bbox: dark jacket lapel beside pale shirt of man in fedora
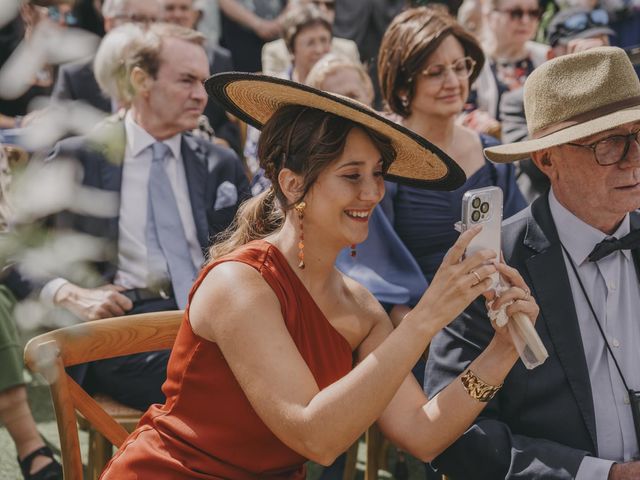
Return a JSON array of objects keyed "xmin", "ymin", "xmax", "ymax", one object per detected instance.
[{"xmin": 524, "ymin": 195, "xmax": 598, "ymax": 452}]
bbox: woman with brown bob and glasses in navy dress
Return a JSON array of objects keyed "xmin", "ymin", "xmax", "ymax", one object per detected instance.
[{"xmin": 376, "ymin": 7, "xmax": 526, "ymax": 348}]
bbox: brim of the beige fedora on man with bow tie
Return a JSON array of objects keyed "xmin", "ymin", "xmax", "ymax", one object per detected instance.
[{"xmin": 484, "ymin": 106, "xmax": 640, "ymax": 163}]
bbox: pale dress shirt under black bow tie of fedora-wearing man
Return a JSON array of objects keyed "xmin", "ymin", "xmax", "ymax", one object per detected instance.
[{"xmin": 549, "ymin": 190, "xmax": 640, "ymax": 480}]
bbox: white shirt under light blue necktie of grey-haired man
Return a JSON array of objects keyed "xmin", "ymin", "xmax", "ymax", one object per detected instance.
[{"xmin": 41, "ymin": 111, "xmax": 204, "ymax": 301}]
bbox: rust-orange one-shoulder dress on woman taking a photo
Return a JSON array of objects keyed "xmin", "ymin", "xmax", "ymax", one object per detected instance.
[{"xmin": 101, "ymin": 240, "xmax": 352, "ymax": 480}]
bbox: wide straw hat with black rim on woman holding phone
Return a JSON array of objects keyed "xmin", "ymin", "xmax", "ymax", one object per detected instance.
[{"xmin": 205, "ymin": 72, "xmax": 466, "ymax": 190}]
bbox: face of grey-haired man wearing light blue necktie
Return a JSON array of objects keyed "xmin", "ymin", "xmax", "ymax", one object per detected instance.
[{"xmin": 134, "ymin": 37, "xmax": 209, "ymax": 138}]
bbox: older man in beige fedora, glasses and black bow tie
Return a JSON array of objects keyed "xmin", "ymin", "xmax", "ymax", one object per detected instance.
[{"xmin": 425, "ymin": 47, "xmax": 640, "ymax": 480}]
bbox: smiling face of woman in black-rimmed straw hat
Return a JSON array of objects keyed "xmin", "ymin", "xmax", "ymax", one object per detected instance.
[{"xmin": 305, "ymin": 128, "xmax": 384, "ymax": 248}]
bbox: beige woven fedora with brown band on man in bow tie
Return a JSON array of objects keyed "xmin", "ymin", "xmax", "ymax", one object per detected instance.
[{"xmin": 484, "ymin": 47, "xmax": 640, "ymax": 162}]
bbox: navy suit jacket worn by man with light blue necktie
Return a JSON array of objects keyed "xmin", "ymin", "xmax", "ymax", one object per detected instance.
[{"xmin": 49, "ymin": 116, "xmax": 251, "ymax": 282}]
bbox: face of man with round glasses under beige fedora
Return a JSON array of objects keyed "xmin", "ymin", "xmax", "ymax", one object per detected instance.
[{"xmin": 534, "ymin": 122, "xmax": 640, "ymax": 232}]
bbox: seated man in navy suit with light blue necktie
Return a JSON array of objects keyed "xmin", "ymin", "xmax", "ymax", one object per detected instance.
[{"xmin": 41, "ymin": 24, "xmax": 250, "ymax": 409}]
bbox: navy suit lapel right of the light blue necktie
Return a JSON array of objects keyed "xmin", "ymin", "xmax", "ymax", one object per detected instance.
[{"xmin": 181, "ymin": 135, "xmax": 209, "ymax": 249}]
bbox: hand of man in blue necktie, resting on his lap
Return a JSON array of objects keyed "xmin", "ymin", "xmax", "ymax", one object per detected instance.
[{"xmin": 53, "ymin": 283, "xmax": 133, "ymax": 320}]
